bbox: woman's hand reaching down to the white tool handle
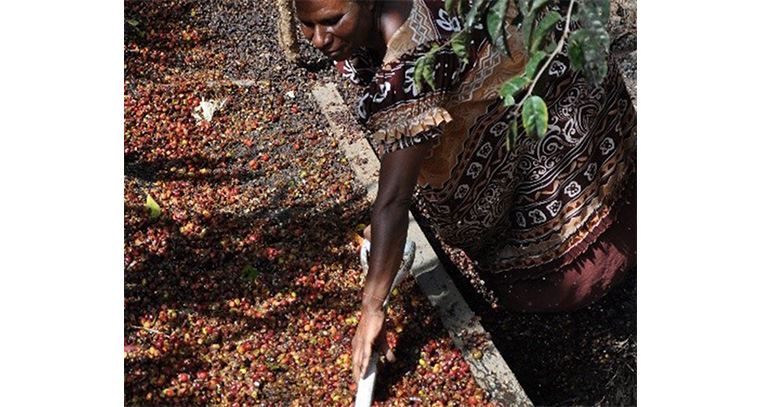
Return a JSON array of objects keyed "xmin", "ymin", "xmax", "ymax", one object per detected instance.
[{"xmin": 351, "ymin": 307, "xmax": 396, "ymax": 382}]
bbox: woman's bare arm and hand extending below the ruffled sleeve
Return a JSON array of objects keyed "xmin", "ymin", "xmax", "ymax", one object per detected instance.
[{"xmin": 352, "ymin": 140, "xmax": 433, "ymax": 380}]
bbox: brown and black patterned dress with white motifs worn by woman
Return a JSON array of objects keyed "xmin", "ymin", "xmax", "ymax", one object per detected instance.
[{"xmin": 337, "ymin": 0, "xmax": 636, "ymax": 298}]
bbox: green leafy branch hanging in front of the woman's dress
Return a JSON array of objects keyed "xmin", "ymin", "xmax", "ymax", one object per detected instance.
[{"xmin": 414, "ymin": 0, "xmax": 610, "ymax": 149}]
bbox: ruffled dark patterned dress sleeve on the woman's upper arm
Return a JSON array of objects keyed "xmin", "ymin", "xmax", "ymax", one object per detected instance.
[{"xmin": 357, "ymin": 43, "xmax": 472, "ymax": 155}]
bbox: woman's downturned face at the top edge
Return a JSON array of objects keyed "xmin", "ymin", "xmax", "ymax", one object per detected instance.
[{"xmin": 296, "ymin": 0, "xmax": 375, "ymax": 61}]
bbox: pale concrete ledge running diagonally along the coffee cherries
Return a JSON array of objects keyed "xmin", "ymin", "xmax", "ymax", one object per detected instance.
[{"xmin": 312, "ymin": 83, "xmax": 533, "ymax": 407}]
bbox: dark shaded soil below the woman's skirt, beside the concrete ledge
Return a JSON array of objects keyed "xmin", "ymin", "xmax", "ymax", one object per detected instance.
[{"xmin": 416, "ymin": 223, "xmax": 637, "ymax": 406}]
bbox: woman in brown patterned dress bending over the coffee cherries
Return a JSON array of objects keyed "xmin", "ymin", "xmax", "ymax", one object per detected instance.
[{"xmin": 296, "ymin": 0, "xmax": 636, "ymax": 379}]
